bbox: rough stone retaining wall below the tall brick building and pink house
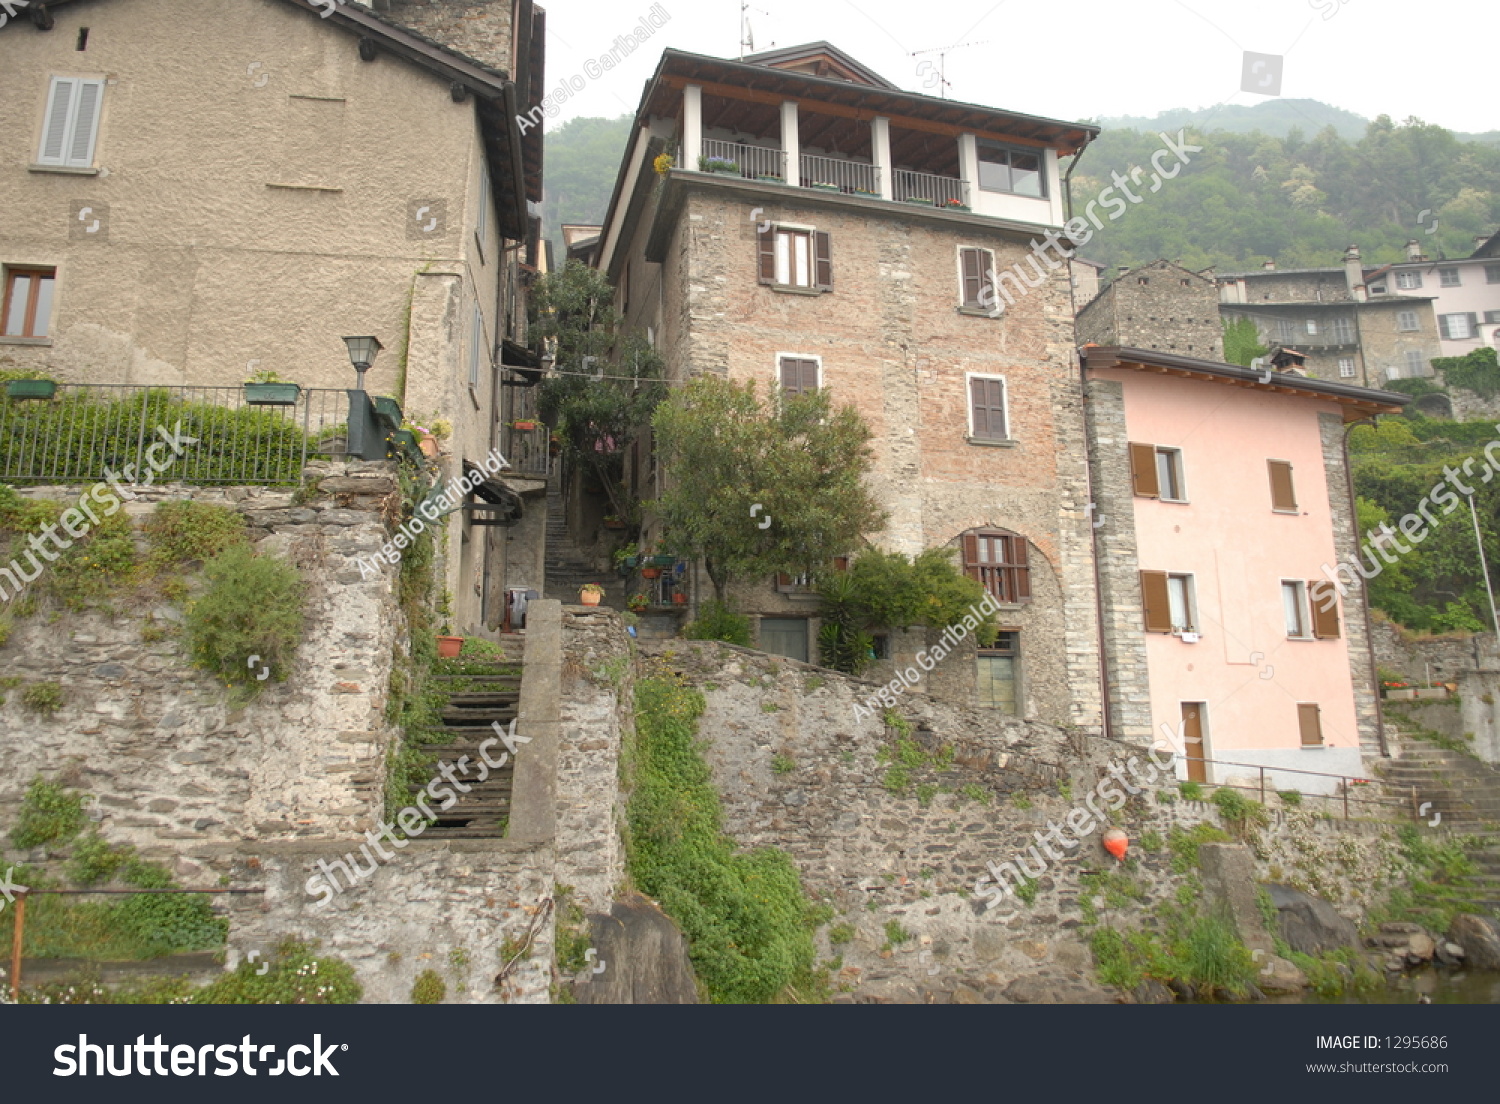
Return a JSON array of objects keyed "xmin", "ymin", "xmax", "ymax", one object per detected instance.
[{"xmin": 642, "ymin": 642, "xmax": 1410, "ymax": 1004}]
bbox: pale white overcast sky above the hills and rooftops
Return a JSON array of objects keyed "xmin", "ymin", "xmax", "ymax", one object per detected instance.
[{"xmin": 542, "ymin": 0, "xmax": 1500, "ymax": 131}]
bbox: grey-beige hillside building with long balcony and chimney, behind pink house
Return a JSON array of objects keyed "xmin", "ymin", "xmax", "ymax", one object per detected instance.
[{"xmin": 1217, "ymin": 246, "xmax": 1440, "ymax": 387}]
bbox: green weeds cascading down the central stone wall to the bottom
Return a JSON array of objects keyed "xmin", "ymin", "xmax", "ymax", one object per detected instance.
[{"xmin": 627, "ymin": 669, "xmax": 821, "ymax": 1004}]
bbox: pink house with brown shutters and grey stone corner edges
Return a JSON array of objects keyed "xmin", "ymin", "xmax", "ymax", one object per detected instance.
[{"xmin": 1083, "ymin": 347, "xmax": 1407, "ymax": 794}]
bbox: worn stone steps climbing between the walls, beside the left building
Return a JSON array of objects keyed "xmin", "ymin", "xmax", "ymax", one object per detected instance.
[{"xmin": 411, "ymin": 633, "xmax": 527, "ymax": 840}]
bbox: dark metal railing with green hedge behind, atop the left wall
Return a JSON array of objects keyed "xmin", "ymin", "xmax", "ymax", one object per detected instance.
[{"xmin": 0, "ymin": 384, "xmax": 348, "ymax": 485}]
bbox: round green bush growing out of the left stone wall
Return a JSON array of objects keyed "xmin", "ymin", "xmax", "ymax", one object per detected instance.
[{"xmin": 185, "ymin": 545, "xmax": 305, "ymax": 699}]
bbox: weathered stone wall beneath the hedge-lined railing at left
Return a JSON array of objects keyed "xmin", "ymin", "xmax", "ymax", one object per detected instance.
[{"xmin": 0, "ymin": 462, "xmax": 402, "ymax": 854}]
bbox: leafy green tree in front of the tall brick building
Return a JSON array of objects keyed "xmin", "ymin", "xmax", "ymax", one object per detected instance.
[{"xmin": 653, "ymin": 375, "xmax": 885, "ymax": 602}]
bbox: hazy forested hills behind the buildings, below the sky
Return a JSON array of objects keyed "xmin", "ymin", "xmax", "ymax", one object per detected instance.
[{"xmin": 543, "ymin": 101, "xmax": 1500, "ymax": 272}]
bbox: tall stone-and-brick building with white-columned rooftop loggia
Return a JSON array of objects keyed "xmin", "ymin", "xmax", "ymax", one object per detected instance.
[{"xmin": 596, "ymin": 44, "xmax": 1100, "ymax": 728}]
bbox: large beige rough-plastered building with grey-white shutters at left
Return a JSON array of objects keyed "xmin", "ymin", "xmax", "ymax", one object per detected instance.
[{"xmin": 0, "ymin": 0, "xmax": 546, "ymax": 639}]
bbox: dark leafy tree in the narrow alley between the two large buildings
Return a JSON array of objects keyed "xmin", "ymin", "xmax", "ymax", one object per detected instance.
[{"xmin": 531, "ymin": 261, "xmax": 666, "ymax": 515}]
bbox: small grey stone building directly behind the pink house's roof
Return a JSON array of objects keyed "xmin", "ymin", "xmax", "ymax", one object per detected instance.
[{"xmin": 1076, "ymin": 261, "xmax": 1224, "ymax": 360}]
